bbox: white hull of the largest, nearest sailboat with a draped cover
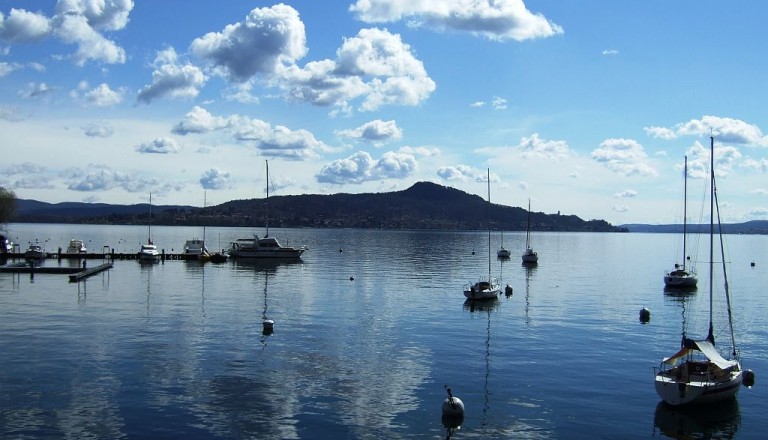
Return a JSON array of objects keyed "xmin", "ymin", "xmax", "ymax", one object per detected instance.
[{"xmin": 655, "ymin": 369, "xmax": 743, "ymax": 406}]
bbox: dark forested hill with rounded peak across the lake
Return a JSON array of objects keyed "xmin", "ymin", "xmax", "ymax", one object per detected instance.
[{"xmin": 13, "ymin": 182, "xmax": 626, "ymax": 232}]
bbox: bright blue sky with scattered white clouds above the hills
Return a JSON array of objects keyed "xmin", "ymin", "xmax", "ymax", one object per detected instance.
[{"xmin": 0, "ymin": 0, "xmax": 768, "ymax": 225}]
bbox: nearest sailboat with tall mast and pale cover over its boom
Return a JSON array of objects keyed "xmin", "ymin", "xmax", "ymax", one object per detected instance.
[{"xmin": 654, "ymin": 138, "xmax": 751, "ymax": 406}]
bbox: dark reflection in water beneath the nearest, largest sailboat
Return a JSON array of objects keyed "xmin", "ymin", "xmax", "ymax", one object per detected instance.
[{"xmin": 653, "ymin": 399, "xmax": 741, "ymax": 439}]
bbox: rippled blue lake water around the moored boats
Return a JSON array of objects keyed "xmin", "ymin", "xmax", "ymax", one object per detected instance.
[{"xmin": 0, "ymin": 224, "xmax": 768, "ymax": 439}]
